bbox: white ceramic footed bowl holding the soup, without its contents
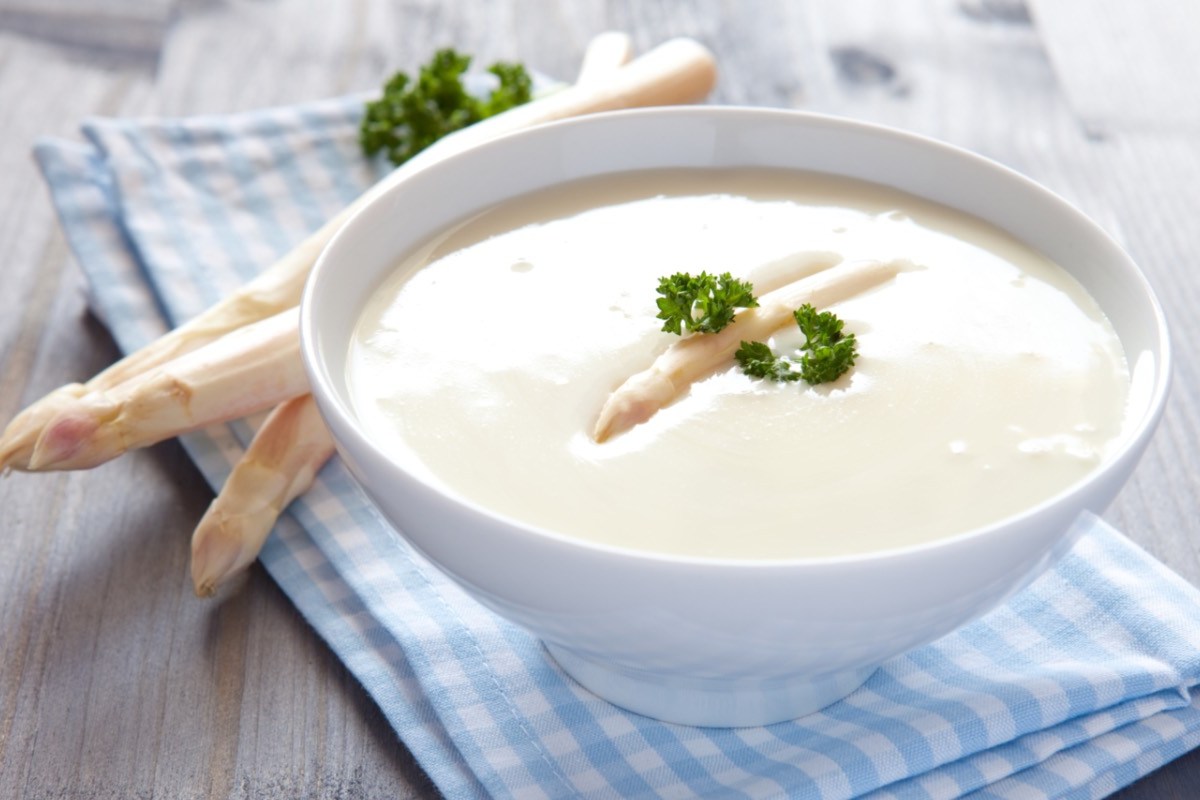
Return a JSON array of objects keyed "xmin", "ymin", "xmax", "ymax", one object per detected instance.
[{"xmin": 301, "ymin": 107, "xmax": 1170, "ymax": 726}]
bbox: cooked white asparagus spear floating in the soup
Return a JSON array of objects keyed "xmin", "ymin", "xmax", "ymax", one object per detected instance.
[{"xmin": 592, "ymin": 261, "xmax": 904, "ymax": 441}]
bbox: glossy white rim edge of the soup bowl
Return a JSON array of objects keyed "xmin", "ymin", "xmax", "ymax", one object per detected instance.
[{"xmin": 300, "ymin": 106, "xmax": 1174, "ymax": 570}]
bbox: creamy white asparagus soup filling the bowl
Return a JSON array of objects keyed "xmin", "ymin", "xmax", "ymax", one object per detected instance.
[{"xmin": 348, "ymin": 170, "xmax": 1129, "ymax": 559}]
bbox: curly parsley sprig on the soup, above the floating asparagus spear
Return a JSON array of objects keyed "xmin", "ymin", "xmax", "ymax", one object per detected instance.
[{"xmin": 658, "ymin": 272, "xmax": 758, "ymax": 335}]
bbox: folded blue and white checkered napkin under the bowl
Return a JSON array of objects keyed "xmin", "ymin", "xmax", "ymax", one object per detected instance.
[{"xmin": 36, "ymin": 100, "xmax": 1200, "ymax": 799}]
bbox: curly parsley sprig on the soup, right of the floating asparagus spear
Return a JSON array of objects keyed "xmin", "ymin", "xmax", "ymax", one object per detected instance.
[{"xmin": 734, "ymin": 303, "xmax": 858, "ymax": 385}]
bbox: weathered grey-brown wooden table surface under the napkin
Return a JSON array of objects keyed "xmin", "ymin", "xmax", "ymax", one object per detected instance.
[{"xmin": 0, "ymin": 0, "xmax": 1200, "ymax": 799}]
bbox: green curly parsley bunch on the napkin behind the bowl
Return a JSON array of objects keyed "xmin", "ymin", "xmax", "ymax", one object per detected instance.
[{"xmin": 359, "ymin": 48, "xmax": 533, "ymax": 167}]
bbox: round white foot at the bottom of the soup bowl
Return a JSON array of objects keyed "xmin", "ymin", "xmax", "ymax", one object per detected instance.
[{"xmin": 545, "ymin": 644, "xmax": 876, "ymax": 728}]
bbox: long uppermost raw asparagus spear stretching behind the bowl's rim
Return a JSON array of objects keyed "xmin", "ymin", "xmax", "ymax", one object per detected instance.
[{"xmin": 0, "ymin": 38, "xmax": 716, "ymax": 471}]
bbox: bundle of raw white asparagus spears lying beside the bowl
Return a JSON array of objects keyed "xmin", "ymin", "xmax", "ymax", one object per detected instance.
[{"xmin": 0, "ymin": 34, "xmax": 715, "ymax": 596}]
